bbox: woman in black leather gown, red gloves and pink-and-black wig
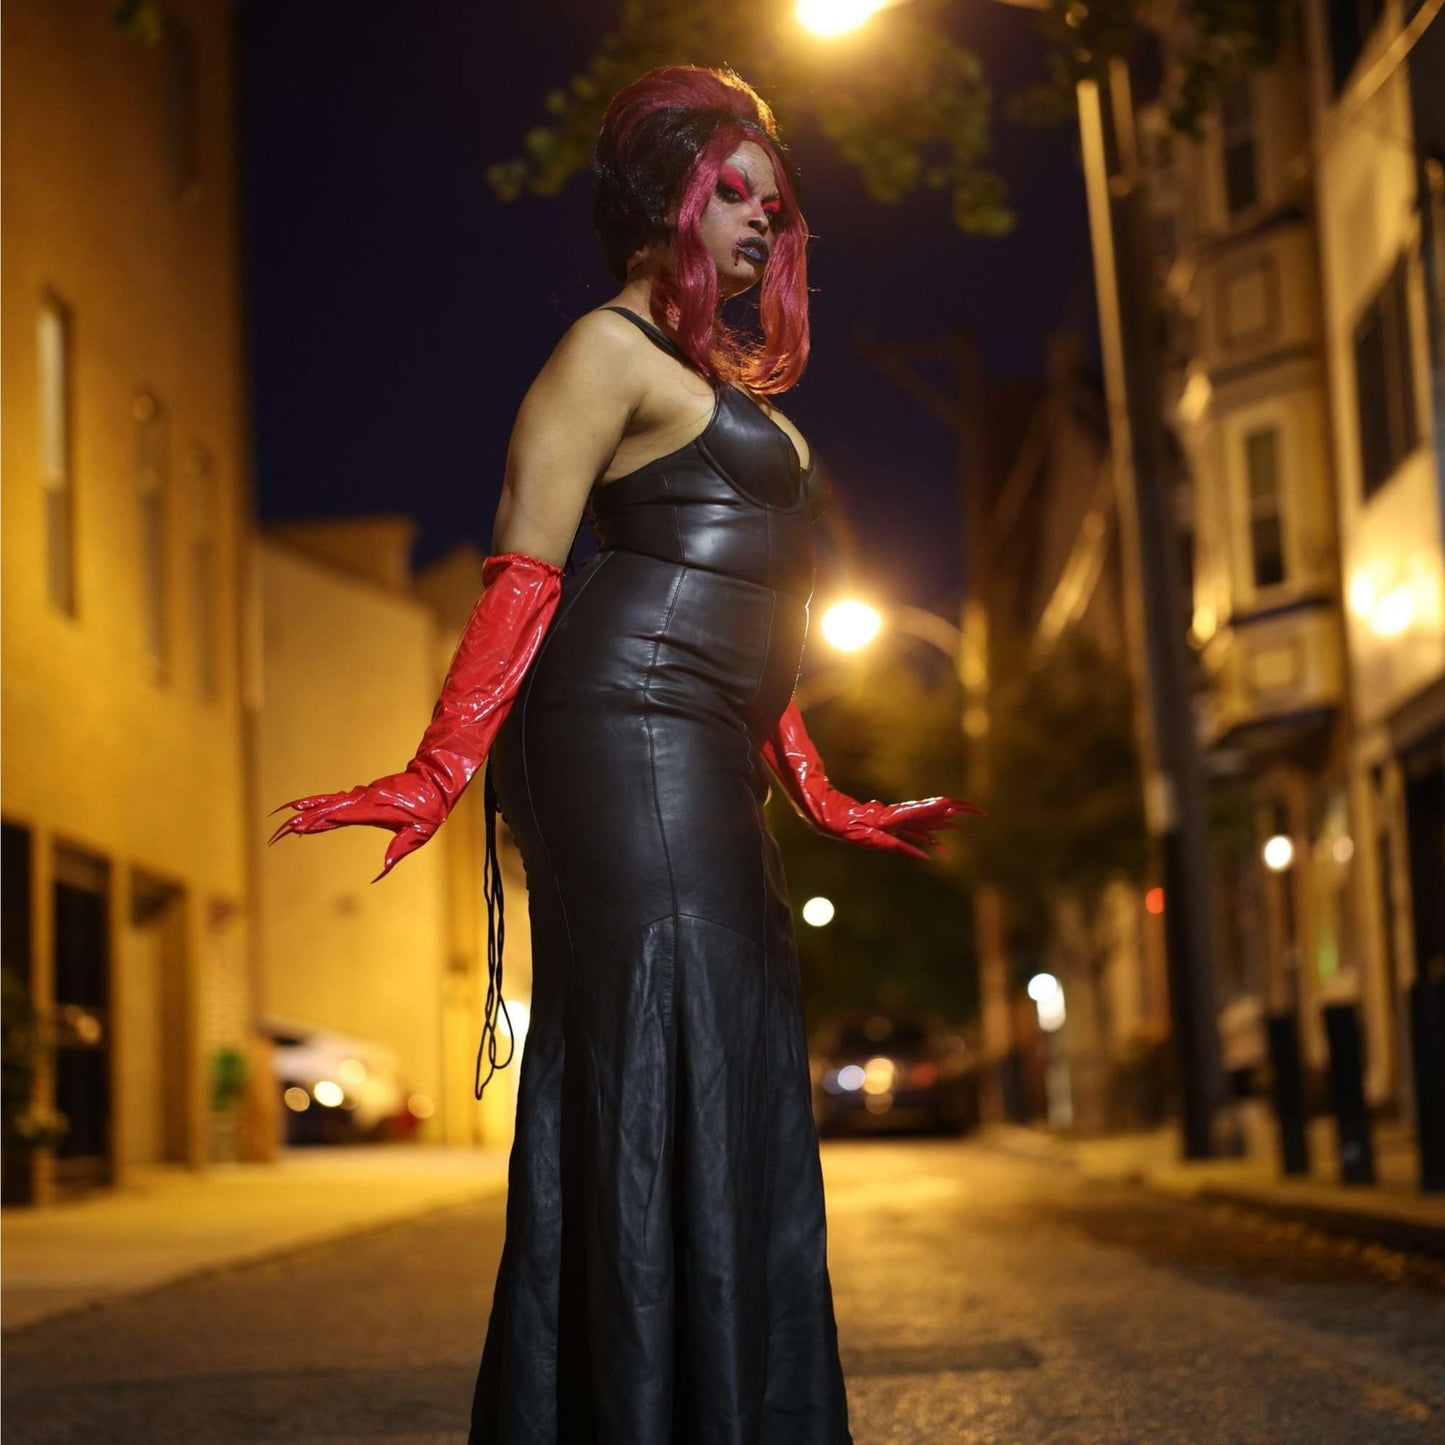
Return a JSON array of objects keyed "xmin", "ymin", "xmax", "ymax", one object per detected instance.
[{"xmin": 273, "ymin": 66, "xmax": 978, "ymax": 1445}]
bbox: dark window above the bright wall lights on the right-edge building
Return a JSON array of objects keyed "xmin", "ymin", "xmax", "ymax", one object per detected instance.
[{"xmin": 1354, "ymin": 254, "xmax": 1420, "ymax": 497}]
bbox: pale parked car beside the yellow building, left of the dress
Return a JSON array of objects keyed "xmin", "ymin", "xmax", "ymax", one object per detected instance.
[{"xmin": 266, "ymin": 1020, "xmax": 413, "ymax": 1144}]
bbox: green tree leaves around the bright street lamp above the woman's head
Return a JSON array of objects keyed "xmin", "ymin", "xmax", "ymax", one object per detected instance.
[{"xmin": 499, "ymin": 0, "xmax": 1290, "ymax": 236}]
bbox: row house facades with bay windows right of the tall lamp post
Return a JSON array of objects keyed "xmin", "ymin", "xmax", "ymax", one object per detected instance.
[{"xmin": 1142, "ymin": 0, "xmax": 1445, "ymax": 1104}]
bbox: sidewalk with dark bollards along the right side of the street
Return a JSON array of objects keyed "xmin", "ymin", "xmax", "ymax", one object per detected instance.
[{"xmin": 974, "ymin": 1120, "xmax": 1445, "ymax": 1260}]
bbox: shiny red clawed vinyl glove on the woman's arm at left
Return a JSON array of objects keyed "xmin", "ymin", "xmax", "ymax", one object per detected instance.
[{"xmin": 270, "ymin": 552, "xmax": 562, "ymax": 883}]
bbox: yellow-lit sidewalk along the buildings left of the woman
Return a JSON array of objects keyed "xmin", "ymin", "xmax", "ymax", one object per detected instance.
[{"xmin": 0, "ymin": 1144, "xmax": 507, "ymax": 1331}]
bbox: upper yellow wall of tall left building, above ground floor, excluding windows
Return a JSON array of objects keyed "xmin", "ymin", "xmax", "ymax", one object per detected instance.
[{"xmin": 3, "ymin": 0, "xmax": 244, "ymax": 896}]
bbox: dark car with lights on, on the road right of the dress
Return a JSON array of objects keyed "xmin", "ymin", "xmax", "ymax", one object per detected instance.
[{"xmin": 809, "ymin": 1010, "xmax": 978, "ymax": 1134}]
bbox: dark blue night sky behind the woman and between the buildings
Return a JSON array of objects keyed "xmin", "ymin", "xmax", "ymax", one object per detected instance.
[{"xmin": 241, "ymin": 0, "xmax": 1092, "ymax": 613}]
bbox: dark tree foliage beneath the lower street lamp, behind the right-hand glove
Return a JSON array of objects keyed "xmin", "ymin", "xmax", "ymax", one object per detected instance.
[{"xmin": 769, "ymin": 631, "xmax": 1147, "ymax": 1020}]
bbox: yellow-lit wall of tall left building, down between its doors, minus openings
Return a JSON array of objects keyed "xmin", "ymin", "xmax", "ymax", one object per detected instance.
[{"xmin": 0, "ymin": 0, "xmax": 249, "ymax": 1184}]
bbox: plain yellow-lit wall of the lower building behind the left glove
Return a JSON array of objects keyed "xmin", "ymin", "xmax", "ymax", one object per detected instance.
[{"xmin": 256, "ymin": 522, "xmax": 450, "ymax": 1140}]
